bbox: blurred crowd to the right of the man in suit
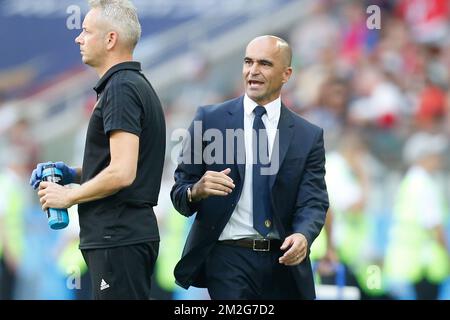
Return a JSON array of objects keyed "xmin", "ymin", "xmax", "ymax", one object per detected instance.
[{"xmin": 288, "ymin": 0, "xmax": 450, "ymax": 299}]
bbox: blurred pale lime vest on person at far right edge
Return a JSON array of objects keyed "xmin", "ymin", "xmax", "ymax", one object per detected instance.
[{"xmin": 385, "ymin": 168, "xmax": 450, "ymax": 283}]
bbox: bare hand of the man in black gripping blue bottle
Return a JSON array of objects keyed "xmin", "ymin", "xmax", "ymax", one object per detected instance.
[{"xmin": 38, "ymin": 181, "xmax": 73, "ymax": 211}]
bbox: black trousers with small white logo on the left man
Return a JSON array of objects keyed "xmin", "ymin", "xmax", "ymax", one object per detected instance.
[{"xmin": 81, "ymin": 241, "xmax": 159, "ymax": 300}]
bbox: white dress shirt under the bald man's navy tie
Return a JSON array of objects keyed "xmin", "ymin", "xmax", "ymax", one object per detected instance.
[{"xmin": 219, "ymin": 95, "xmax": 281, "ymax": 240}]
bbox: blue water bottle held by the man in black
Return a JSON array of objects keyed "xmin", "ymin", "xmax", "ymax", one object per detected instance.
[{"xmin": 42, "ymin": 163, "xmax": 69, "ymax": 230}]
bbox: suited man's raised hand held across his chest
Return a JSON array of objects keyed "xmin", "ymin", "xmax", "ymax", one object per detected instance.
[{"xmin": 191, "ymin": 168, "xmax": 234, "ymax": 201}]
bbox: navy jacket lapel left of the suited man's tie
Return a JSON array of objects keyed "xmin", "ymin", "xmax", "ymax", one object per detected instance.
[{"xmin": 229, "ymin": 96, "xmax": 245, "ymax": 181}]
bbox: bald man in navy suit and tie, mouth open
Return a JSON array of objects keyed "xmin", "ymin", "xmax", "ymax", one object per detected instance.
[{"xmin": 171, "ymin": 36, "xmax": 328, "ymax": 299}]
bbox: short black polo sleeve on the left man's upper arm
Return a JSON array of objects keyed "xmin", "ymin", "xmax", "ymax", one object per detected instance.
[{"xmin": 102, "ymin": 80, "xmax": 143, "ymax": 136}]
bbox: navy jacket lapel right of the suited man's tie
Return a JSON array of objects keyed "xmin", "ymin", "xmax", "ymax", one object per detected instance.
[{"xmin": 269, "ymin": 104, "xmax": 294, "ymax": 188}]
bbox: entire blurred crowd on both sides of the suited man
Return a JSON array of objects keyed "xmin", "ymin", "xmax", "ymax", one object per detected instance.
[{"xmin": 0, "ymin": 0, "xmax": 450, "ymax": 299}]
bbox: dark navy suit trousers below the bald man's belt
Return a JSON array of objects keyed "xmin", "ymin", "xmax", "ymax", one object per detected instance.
[{"xmin": 206, "ymin": 242, "xmax": 302, "ymax": 300}]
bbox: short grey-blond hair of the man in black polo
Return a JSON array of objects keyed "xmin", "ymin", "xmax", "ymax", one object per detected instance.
[{"xmin": 88, "ymin": 0, "xmax": 141, "ymax": 50}]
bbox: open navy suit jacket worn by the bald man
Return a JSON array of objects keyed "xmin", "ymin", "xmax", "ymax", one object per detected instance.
[{"xmin": 171, "ymin": 97, "xmax": 328, "ymax": 299}]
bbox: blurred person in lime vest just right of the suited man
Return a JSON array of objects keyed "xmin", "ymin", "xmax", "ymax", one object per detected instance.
[{"xmin": 325, "ymin": 130, "xmax": 390, "ymax": 298}]
